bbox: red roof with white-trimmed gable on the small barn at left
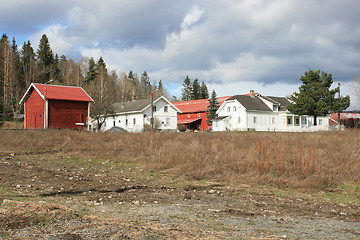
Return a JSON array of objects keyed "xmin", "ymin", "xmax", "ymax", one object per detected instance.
[{"xmin": 21, "ymin": 83, "xmax": 94, "ymax": 102}]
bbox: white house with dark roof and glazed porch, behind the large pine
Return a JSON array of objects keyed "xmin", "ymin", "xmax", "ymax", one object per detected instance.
[{"xmin": 213, "ymin": 91, "xmax": 329, "ymax": 132}]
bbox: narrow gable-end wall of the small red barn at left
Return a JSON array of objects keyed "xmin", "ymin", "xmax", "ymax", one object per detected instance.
[{"xmin": 25, "ymin": 90, "xmax": 45, "ymax": 129}]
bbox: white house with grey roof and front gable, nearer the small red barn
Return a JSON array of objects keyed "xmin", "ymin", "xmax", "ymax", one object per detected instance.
[{"xmin": 101, "ymin": 96, "xmax": 181, "ymax": 132}]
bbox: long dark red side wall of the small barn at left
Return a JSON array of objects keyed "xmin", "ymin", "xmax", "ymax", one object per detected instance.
[{"xmin": 48, "ymin": 99, "xmax": 88, "ymax": 129}]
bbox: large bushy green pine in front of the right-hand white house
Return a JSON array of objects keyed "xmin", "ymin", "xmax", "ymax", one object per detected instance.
[{"xmin": 288, "ymin": 70, "xmax": 350, "ymax": 125}]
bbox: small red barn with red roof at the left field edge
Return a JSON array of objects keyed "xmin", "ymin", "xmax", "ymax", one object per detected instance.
[{"xmin": 20, "ymin": 83, "xmax": 94, "ymax": 129}]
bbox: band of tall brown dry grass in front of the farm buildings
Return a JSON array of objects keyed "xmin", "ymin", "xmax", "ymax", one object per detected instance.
[{"xmin": 0, "ymin": 130, "xmax": 360, "ymax": 187}]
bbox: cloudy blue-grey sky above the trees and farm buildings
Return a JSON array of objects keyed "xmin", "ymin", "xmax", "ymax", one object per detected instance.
[{"xmin": 0, "ymin": 0, "xmax": 360, "ymax": 109}]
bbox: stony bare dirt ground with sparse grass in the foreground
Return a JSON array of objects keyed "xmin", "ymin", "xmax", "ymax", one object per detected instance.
[{"xmin": 0, "ymin": 131, "xmax": 360, "ymax": 239}]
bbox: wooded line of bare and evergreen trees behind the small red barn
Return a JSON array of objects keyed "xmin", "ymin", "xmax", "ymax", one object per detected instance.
[{"xmin": 0, "ymin": 34, "xmax": 168, "ymax": 123}]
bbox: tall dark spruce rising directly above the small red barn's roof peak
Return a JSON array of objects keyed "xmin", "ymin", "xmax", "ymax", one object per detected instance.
[{"xmin": 37, "ymin": 34, "xmax": 54, "ymax": 83}]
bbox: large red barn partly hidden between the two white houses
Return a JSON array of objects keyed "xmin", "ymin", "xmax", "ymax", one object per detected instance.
[{"xmin": 173, "ymin": 96, "xmax": 231, "ymax": 131}]
